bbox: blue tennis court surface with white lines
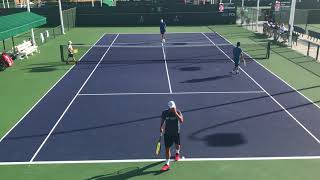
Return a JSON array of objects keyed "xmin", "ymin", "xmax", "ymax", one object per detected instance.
[{"xmin": 0, "ymin": 33, "xmax": 320, "ymax": 163}]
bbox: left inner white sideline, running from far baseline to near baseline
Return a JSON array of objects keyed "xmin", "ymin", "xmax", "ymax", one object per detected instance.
[{"xmin": 30, "ymin": 34, "xmax": 119, "ymax": 162}]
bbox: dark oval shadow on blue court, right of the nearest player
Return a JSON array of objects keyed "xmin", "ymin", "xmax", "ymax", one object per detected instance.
[{"xmin": 202, "ymin": 133, "xmax": 247, "ymax": 147}]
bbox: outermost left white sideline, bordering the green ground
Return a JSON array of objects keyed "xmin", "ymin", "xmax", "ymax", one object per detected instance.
[{"xmin": 0, "ymin": 34, "xmax": 105, "ymax": 142}]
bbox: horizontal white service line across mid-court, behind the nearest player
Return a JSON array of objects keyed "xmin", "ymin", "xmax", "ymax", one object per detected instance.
[{"xmin": 78, "ymin": 91, "xmax": 265, "ymax": 96}]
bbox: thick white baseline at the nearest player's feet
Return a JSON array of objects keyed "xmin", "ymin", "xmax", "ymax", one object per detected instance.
[{"xmin": 0, "ymin": 156, "xmax": 320, "ymax": 166}]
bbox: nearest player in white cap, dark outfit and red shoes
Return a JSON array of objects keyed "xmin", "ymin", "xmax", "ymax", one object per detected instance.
[{"xmin": 160, "ymin": 101, "xmax": 183, "ymax": 171}]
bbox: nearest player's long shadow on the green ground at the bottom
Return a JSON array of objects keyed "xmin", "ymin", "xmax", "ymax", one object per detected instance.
[{"xmin": 85, "ymin": 161, "xmax": 163, "ymax": 180}]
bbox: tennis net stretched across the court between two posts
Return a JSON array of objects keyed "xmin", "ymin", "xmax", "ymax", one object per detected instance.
[{"xmin": 60, "ymin": 42, "xmax": 271, "ymax": 62}]
